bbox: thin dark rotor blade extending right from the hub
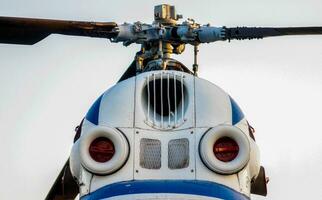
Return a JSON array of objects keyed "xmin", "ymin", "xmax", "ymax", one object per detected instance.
[{"xmin": 224, "ymin": 27, "xmax": 322, "ymax": 40}]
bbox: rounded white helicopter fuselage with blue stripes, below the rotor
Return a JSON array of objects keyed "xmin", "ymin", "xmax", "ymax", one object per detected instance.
[{"xmin": 70, "ymin": 70, "xmax": 260, "ymax": 200}]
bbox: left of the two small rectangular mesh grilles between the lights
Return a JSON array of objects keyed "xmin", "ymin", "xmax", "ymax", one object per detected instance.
[{"xmin": 140, "ymin": 138, "xmax": 161, "ymax": 169}]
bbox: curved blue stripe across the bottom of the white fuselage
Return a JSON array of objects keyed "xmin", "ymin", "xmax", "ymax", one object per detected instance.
[{"xmin": 81, "ymin": 180, "xmax": 249, "ymax": 200}]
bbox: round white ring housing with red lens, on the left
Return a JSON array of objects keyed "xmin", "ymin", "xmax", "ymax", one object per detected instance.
[{"xmin": 79, "ymin": 126, "xmax": 130, "ymax": 175}]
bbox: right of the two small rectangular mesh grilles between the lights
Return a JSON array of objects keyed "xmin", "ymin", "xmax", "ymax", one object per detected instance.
[{"xmin": 168, "ymin": 138, "xmax": 189, "ymax": 169}]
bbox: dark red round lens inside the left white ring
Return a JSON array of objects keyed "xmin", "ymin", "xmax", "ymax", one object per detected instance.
[{"xmin": 89, "ymin": 137, "xmax": 115, "ymax": 163}]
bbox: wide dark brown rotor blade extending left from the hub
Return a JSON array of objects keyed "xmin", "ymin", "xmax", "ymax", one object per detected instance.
[{"xmin": 0, "ymin": 17, "xmax": 118, "ymax": 45}]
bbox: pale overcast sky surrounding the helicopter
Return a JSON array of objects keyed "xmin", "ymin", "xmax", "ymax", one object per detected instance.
[{"xmin": 0, "ymin": 0, "xmax": 322, "ymax": 200}]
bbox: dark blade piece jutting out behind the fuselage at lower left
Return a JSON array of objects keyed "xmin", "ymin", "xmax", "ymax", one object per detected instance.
[{"xmin": 45, "ymin": 160, "xmax": 79, "ymax": 200}]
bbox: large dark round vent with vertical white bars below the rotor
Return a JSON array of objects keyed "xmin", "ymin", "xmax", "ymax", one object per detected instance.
[{"xmin": 143, "ymin": 72, "xmax": 187, "ymax": 129}]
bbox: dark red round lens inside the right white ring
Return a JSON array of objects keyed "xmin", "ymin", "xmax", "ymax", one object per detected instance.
[{"xmin": 213, "ymin": 137, "xmax": 239, "ymax": 162}]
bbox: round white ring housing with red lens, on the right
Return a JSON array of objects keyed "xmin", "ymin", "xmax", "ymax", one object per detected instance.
[{"xmin": 199, "ymin": 124, "xmax": 250, "ymax": 174}]
